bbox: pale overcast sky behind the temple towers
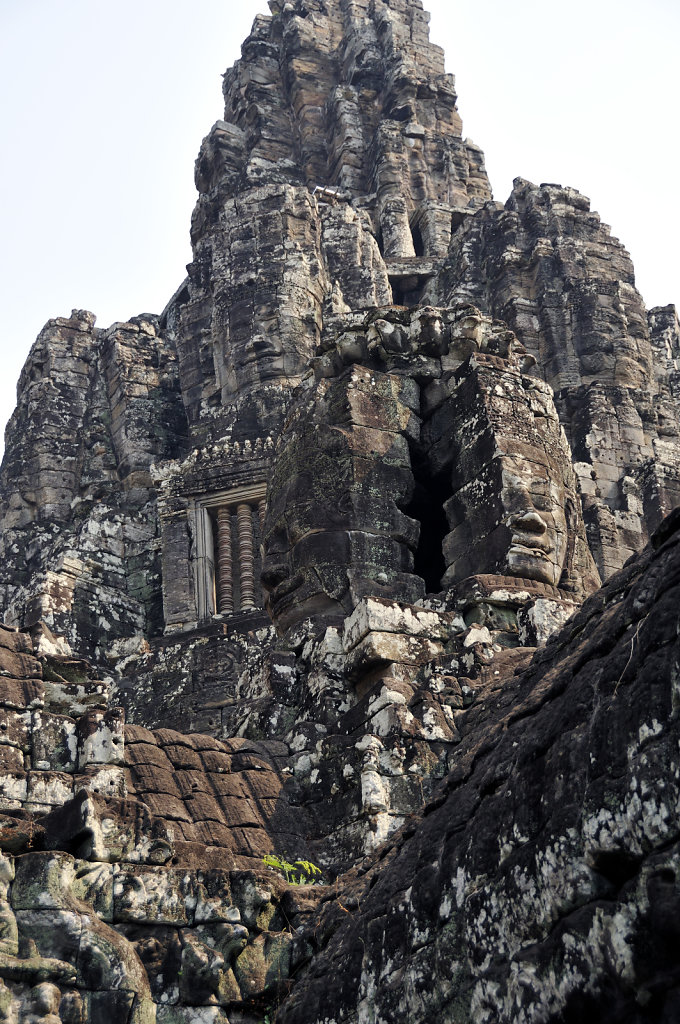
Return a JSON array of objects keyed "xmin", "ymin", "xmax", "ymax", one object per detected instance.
[{"xmin": 0, "ymin": 0, "xmax": 680, "ymax": 452}]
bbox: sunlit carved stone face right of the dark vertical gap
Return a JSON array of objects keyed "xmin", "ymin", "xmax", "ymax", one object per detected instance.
[{"xmin": 439, "ymin": 356, "xmax": 593, "ymax": 590}]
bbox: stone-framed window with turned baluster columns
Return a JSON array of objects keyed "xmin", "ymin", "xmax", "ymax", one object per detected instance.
[{"xmin": 196, "ymin": 483, "xmax": 266, "ymax": 622}]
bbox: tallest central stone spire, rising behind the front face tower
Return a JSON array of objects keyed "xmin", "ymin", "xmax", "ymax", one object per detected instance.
[{"xmin": 176, "ymin": 0, "xmax": 491, "ymax": 452}]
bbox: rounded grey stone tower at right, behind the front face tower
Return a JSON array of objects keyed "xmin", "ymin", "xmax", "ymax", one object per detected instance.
[{"xmin": 425, "ymin": 178, "xmax": 680, "ymax": 578}]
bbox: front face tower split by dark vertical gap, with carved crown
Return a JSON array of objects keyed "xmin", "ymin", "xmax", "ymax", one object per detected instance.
[{"xmin": 262, "ymin": 305, "xmax": 599, "ymax": 630}]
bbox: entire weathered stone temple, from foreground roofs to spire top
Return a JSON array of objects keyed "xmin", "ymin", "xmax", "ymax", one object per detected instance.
[{"xmin": 0, "ymin": 0, "xmax": 680, "ymax": 1024}]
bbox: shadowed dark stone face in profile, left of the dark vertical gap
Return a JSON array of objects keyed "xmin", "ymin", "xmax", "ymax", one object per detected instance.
[{"xmin": 261, "ymin": 367, "xmax": 423, "ymax": 631}]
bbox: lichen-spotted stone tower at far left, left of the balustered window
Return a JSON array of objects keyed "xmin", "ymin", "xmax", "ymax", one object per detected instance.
[{"xmin": 0, "ymin": 310, "xmax": 186, "ymax": 659}]
